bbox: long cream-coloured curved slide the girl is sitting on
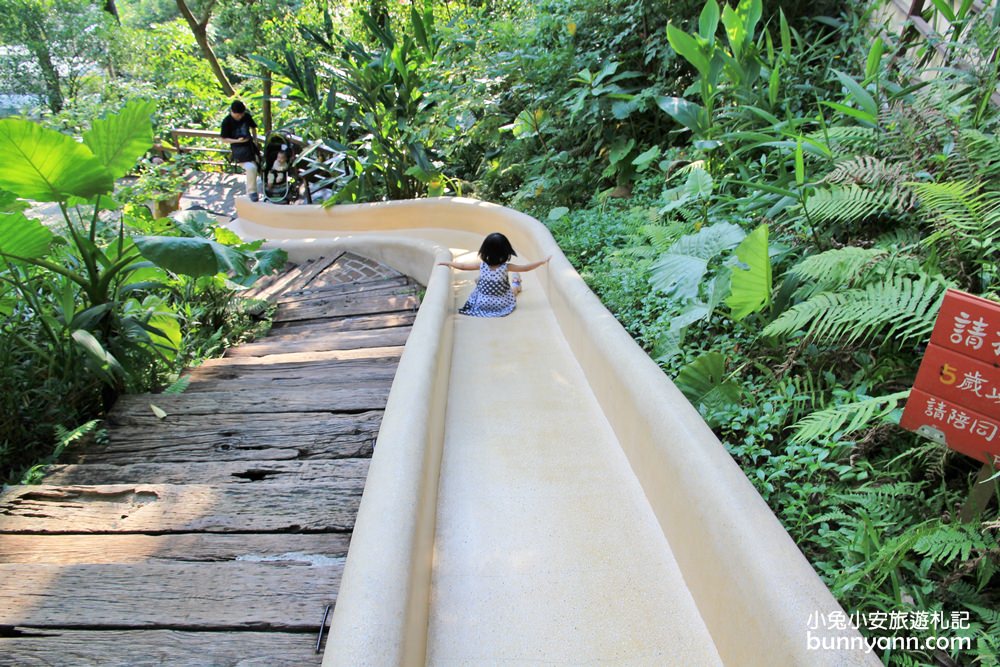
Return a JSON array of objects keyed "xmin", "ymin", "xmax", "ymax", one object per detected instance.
[{"xmin": 234, "ymin": 199, "xmax": 879, "ymax": 667}]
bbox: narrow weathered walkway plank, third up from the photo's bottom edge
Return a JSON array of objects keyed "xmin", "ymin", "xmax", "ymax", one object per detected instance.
[{"xmin": 0, "ymin": 533, "xmax": 351, "ymax": 565}]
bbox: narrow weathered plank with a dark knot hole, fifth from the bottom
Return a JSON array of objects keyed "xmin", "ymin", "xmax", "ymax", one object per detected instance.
[{"xmin": 36, "ymin": 458, "xmax": 369, "ymax": 492}]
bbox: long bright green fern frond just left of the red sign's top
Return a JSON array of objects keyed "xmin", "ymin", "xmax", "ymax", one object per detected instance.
[{"xmin": 763, "ymin": 275, "xmax": 946, "ymax": 345}]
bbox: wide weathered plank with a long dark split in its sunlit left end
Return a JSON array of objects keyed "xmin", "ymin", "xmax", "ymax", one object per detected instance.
[{"xmin": 0, "ymin": 483, "xmax": 363, "ymax": 536}]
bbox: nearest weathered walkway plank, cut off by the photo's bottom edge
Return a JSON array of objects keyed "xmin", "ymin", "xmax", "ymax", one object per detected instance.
[{"xmin": 0, "ymin": 632, "xmax": 323, "ymax": 667}]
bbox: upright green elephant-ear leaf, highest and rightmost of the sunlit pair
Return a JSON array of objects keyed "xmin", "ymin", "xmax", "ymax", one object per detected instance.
[{"xmin": 83, "ymin": 100, "xmax": 156, "ymax": 178}]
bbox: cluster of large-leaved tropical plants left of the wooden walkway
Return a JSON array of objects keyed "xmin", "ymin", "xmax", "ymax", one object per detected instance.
[{"xmin": 0, "ymin": 100, "xmax": 284, "ymax": 477}]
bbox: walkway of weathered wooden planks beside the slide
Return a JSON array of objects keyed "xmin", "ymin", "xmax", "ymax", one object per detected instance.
[{"xmin": 0, "ymin": 254, "xmax": 419, "ymax": 667}]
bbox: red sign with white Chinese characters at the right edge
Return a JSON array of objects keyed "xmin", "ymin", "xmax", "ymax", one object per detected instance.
[{"xmin": 900, "ymin": 290, "xmax": 1000, "ymax": 465}]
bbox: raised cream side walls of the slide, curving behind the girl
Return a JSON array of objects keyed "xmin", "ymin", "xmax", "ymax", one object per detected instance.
[{"xmin": 234, "ymin": 199, "xmax": 880, "ymax": 666}]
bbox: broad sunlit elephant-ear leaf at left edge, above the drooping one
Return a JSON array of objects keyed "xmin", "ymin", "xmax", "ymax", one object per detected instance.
[{"xmin": 0, "ymin": 118, "xmax": 114, "ymax": 201}]
